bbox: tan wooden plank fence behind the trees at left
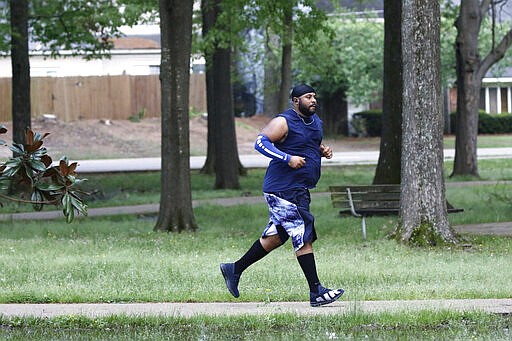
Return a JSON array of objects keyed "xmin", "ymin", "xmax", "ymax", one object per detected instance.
[{"xmin": 0, "ymin": 74, "xmax": 206, "ymax": 123}]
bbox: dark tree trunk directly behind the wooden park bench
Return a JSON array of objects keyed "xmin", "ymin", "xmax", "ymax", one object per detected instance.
[{"xmin": 373, "ymin": 0, "xmax": 403, "ymax": 184}]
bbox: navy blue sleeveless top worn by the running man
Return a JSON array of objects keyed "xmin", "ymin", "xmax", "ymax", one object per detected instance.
[{"xmin": 263, "ymin": 109, "xmax": 323, "ymax": 193}]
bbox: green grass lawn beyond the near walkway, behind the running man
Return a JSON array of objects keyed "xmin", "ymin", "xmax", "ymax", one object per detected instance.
[{"xmin": 0, "ymin": 160, "xmax": 512, "ymax": 302}]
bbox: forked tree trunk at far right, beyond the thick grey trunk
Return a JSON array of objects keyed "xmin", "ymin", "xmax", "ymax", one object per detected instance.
[{"xmin": 452, "ymin": 0, "xmax": 512, "ymax": 177}]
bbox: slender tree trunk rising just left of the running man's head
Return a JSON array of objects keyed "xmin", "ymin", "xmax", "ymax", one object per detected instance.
[{"xmin": 279, "ymin": 2, "xmax": 293, "ymax": 111}]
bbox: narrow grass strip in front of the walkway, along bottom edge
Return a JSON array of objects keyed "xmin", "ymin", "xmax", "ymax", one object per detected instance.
[{"xmin": 0, "ymin": 311, "xmax": 512, "ymax": 340}]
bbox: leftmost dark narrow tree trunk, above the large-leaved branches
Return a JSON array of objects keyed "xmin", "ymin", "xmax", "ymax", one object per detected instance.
[{"xmin": 10, "ymin": 0, "xmax": 31, "ymax": 145}]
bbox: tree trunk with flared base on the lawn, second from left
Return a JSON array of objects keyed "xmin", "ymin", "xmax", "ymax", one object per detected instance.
[{"xmin": 154, "ymin": 0, "xmax": 197, "ymax": 232}]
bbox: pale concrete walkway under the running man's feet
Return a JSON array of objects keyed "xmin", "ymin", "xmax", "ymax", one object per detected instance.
[{"xmin": 0, "ymin": 298, "xmax": 512, "ymax": 317}]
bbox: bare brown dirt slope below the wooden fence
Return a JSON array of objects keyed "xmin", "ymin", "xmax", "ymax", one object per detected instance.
[{"xmin": 0, "ymin": 116, "xmax": 379, "ymax": 160}]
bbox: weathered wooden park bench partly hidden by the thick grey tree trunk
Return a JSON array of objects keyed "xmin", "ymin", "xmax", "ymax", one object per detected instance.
[{"xmin": 329, "ymin": 185, "xmax": 464, "ymax": 239}]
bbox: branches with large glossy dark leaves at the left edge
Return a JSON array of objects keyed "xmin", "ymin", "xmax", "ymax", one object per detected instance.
[{"xmin": 0, "ymin": 125, "xmax": 87, "ymax": 223}]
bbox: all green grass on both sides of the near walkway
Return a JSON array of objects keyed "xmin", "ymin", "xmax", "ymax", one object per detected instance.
[{"xmin": 0, "ymin": 160, "xmax": 512, "ymax": 339}]
